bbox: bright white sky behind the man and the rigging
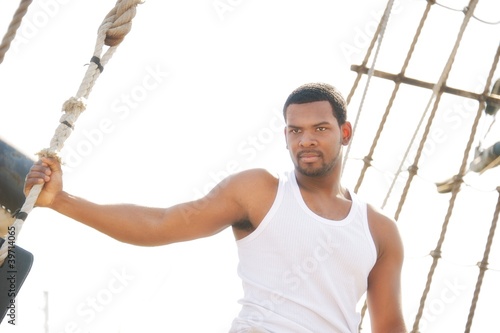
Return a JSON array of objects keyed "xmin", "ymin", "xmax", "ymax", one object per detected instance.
[{"xmin": 0, "ymin": 0, "xmax": 500, "ymax": 333}]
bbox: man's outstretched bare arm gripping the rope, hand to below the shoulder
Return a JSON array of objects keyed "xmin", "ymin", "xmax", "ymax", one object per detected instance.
[{"xmin": 25, "ymin": 158, "xmax": 247, "ymax": 246}]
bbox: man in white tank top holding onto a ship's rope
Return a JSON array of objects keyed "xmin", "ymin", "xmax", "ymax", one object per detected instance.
[{"xmin": 25, "ymin": 83, "xmax": 406, "ymax": 333}]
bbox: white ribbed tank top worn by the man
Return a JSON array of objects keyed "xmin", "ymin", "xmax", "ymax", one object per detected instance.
[{"xmin": 230, "ymin": 171, "xmax": 377, "ymax": 333}]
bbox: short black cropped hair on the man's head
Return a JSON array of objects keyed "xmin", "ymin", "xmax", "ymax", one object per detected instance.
[{"xmin": 283, "ymin": 82, "xmax": 347, "ymax": 125}]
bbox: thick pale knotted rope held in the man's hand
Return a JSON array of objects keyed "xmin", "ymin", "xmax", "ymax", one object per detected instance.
[{"xmin": 0, "ymin": 0, "xmax": 142, "ymax": 265}]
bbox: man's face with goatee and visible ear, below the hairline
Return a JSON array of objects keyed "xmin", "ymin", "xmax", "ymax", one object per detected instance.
[{"xmin": 285, "ymin": 101, "xmax": 351, "ymax": 177}]
